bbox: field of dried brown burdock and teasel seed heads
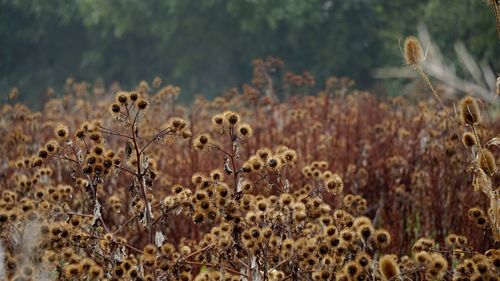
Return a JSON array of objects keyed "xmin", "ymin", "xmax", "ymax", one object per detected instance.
[{"xmin": 0, "ymin": 51, "xmax": 500, "ymax": 281}]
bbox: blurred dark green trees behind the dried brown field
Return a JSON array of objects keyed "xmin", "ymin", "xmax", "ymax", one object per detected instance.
[{"xmin": 0, "ymin": 0, "xmax": 500, "ymax": 105}]
